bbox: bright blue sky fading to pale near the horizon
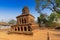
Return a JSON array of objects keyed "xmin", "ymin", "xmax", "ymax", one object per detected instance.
[{"xmin": 0, "ymin": 0, "xmax": 51, "ymax": 21}]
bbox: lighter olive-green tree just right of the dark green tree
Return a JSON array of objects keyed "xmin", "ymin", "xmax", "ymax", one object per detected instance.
[{"xmin": 46, "ymin": 13, "xmax": 56, "ymax": 27}]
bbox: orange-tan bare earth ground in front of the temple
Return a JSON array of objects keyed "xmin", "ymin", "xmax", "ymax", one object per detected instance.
[{"xmin": 0, "ymin": 29, "xmax": 60, "ymax": 40}]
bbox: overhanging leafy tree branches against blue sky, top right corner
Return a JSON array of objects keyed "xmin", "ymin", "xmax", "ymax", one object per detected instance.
[{"xmin": 36, "ymin": 0, "xmax": 60, "ymax": 14}]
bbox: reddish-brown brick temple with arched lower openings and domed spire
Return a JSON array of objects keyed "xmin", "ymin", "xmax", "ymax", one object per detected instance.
[{"xmin": 10, "ymin": 7, "xmax": 38, "ymax": 34}]
